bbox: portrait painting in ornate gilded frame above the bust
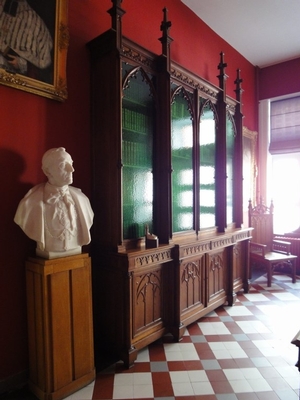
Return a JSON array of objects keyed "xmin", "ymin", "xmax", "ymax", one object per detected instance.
[{"xmin": 0, "ymin": 0, "xmax": 69, "ymax": 101}]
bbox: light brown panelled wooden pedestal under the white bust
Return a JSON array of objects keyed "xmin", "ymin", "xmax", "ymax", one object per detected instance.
[{"xmin": 26, "ymin": 254, "xmax": 95, "ymax": 400}]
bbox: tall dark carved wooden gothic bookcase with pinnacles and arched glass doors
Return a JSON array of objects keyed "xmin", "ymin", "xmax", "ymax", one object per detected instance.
[{"xmin": 88, "ymin": 0, "xmax": 251, "ymax": 367}]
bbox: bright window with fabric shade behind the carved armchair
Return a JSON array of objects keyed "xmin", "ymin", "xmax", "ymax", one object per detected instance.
[{"xmin": 269, "ymin": 97, "xmax": 300, "ymax": 234}]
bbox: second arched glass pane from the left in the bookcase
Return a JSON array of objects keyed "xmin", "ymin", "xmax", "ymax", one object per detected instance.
[{"xmin": 171, "ymin": 85, "xmax": 194, "ymax": 232}]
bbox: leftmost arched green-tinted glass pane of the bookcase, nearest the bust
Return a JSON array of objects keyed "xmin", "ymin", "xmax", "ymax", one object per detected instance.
[{"xmin": 122, "ymin": 63, "xmax": 155, "ymax": 239}]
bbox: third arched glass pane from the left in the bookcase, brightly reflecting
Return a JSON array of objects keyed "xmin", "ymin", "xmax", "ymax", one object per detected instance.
[{"xmin": 199, "ymin": 99, "xmax": 216, "ymax": 229}]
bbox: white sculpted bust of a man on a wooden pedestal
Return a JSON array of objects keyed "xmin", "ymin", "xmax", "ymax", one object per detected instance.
[{"xmin": 14, "ymin": 147, "xmax": 94, "ymax": 258}]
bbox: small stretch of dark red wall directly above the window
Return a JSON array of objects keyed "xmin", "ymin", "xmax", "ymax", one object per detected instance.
[{"xmin": 259, "ymin": 57, "xmax": 300, "ymax": 100}]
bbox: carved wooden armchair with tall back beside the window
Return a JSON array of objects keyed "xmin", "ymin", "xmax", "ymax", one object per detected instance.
[{"xmin": 249, "ymin": 200, "xmax": 297, "ymax": 286}]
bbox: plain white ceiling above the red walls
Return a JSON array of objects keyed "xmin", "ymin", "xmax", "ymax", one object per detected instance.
[{"xmin": 181, "ymin": 0, "xmax": 300, "ymax": 68}]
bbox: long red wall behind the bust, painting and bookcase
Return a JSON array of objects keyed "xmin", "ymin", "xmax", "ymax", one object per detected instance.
[{"xmin": 0, "ymin": 0, "xmax": 257, "ymax": 388}]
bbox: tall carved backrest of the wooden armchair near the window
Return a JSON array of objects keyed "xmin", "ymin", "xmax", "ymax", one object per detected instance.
[{"xmin": 248, "ymin": 200, "xmax": 274, "ymax": 251}]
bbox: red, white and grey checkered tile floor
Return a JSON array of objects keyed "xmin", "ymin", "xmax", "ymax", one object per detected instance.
[{"xmin": 67, "ymin": 275, "xmax": 300, "ymax": 400}]
